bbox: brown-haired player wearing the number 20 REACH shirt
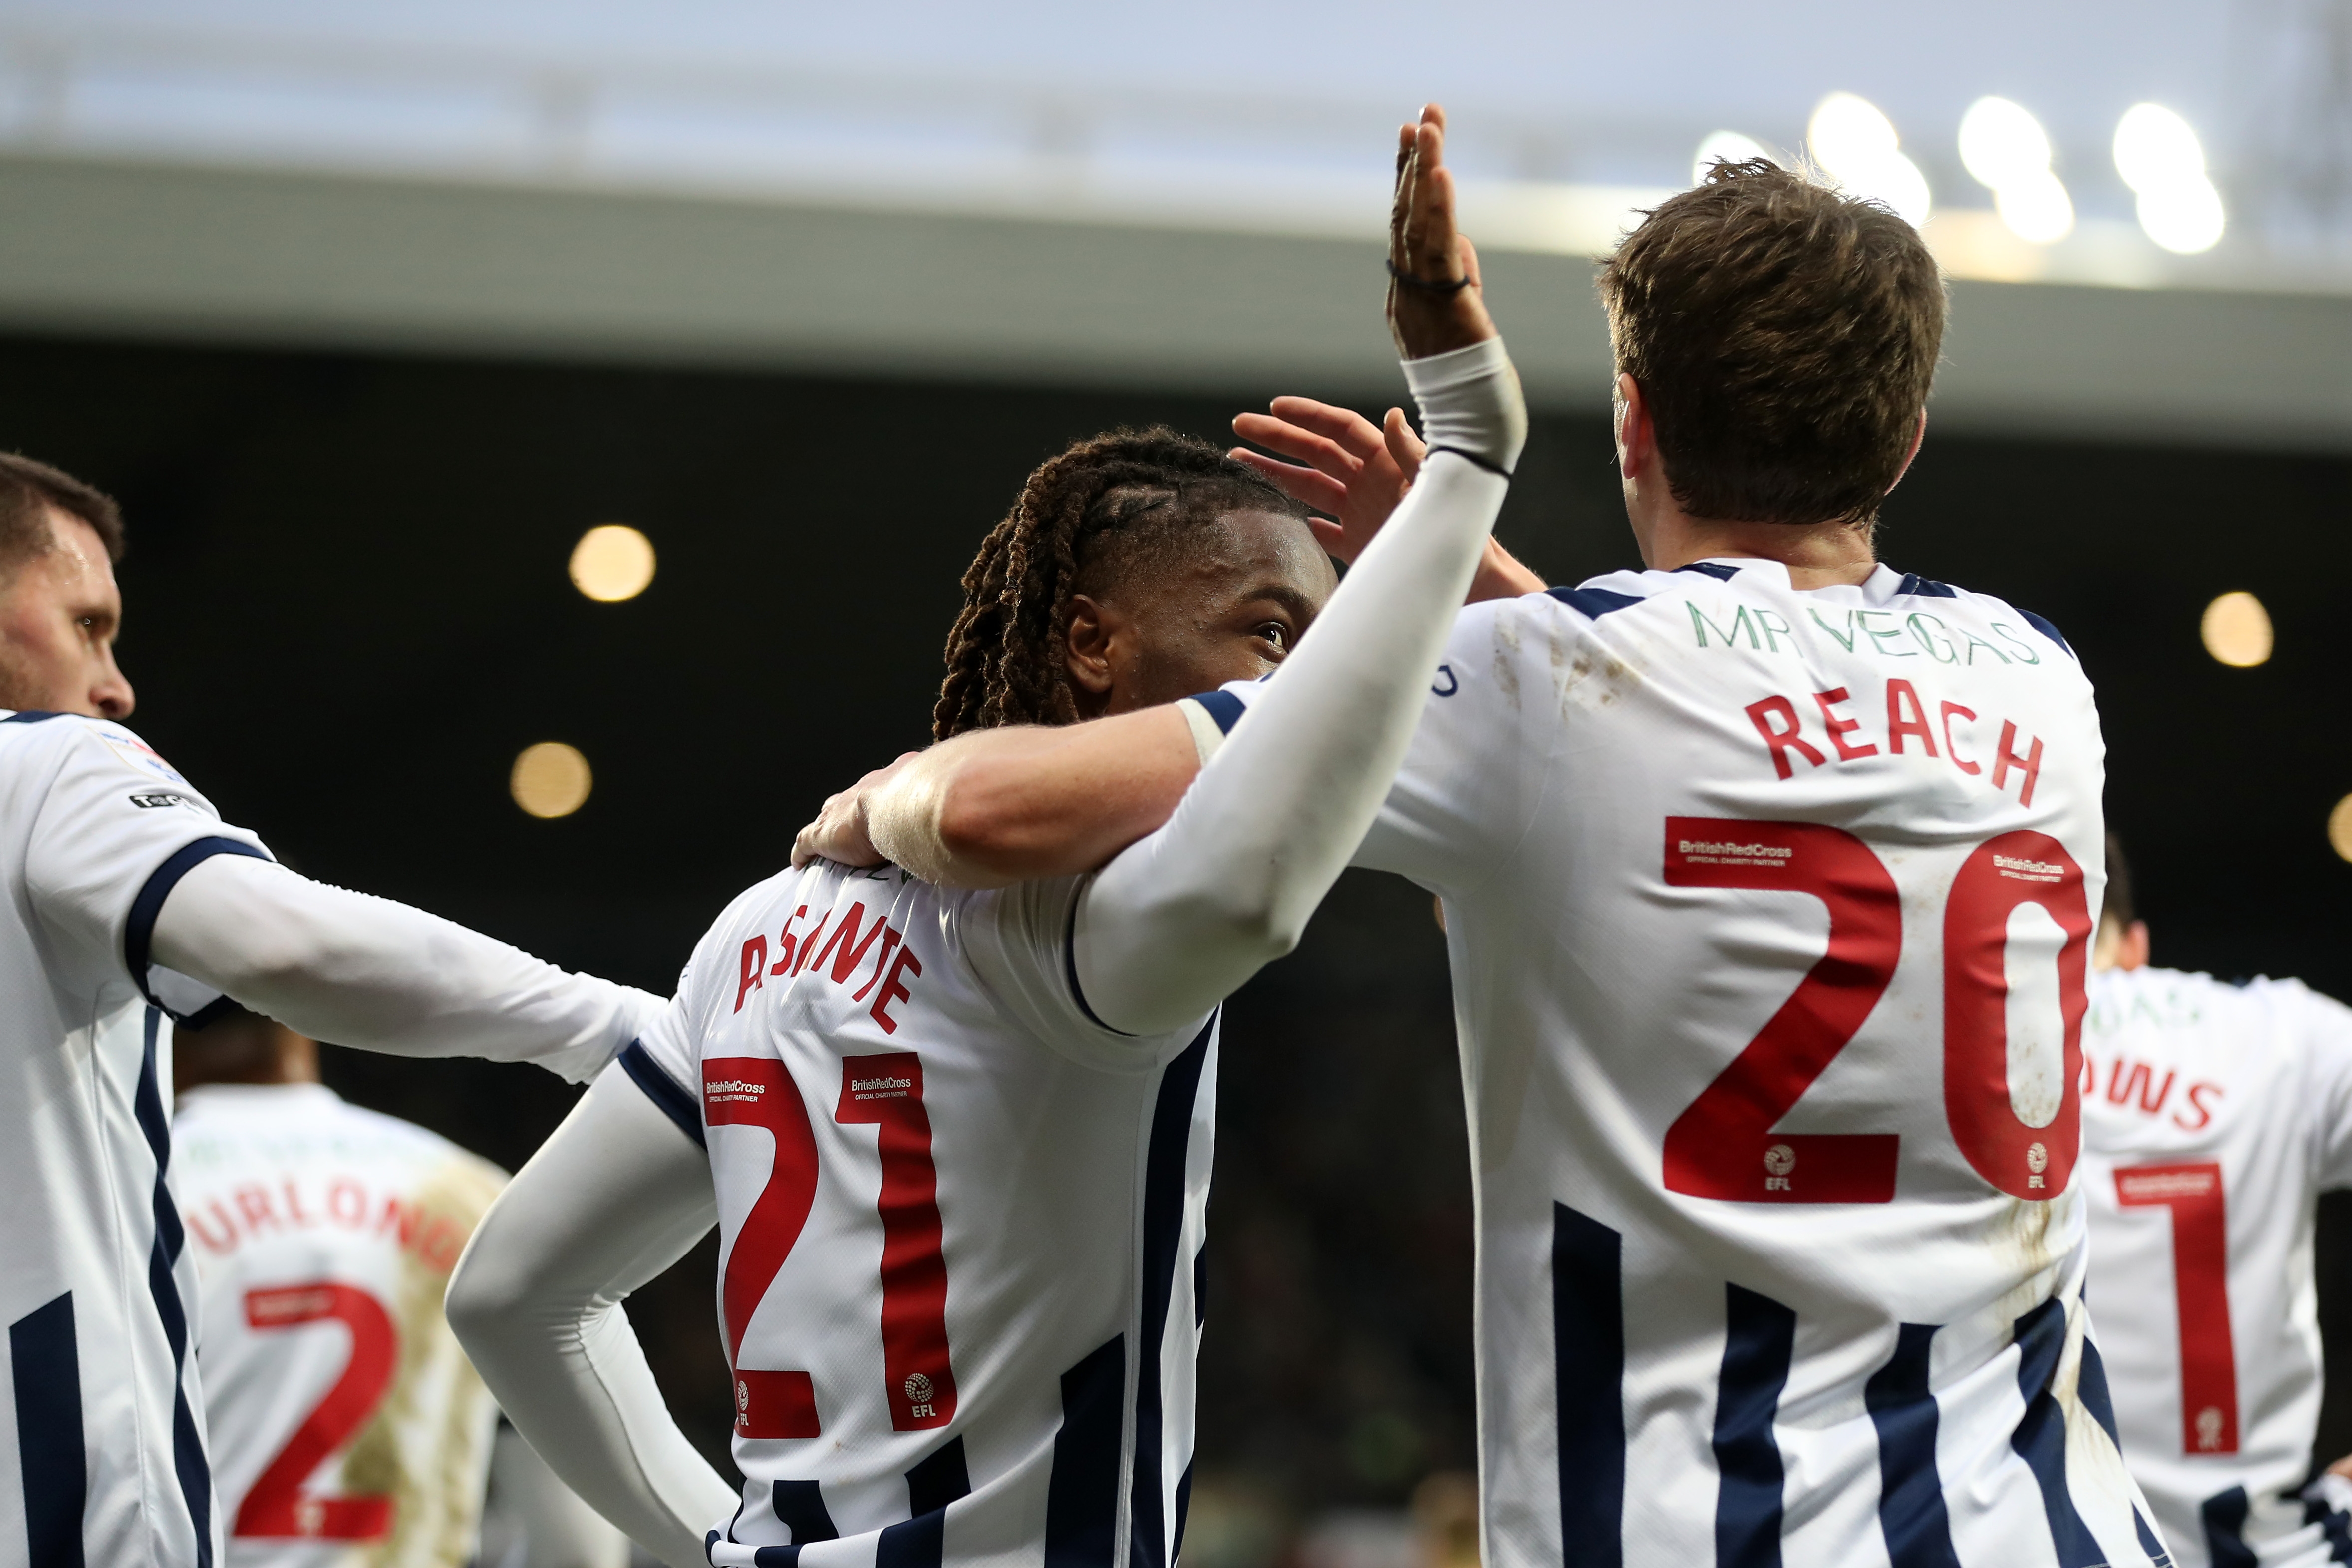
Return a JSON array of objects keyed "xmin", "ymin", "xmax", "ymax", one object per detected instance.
[{"xmin": 805, "ymin": 162, "xmax": 2166, "ymax": 1568}]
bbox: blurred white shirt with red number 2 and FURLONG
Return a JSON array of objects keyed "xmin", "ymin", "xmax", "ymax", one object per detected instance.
[{"xmin": 172, "ymin": 1084, "xmax": 506, "ymax": 1568}]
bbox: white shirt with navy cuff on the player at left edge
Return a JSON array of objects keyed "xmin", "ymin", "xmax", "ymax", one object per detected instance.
[{"xmin": 0, "ymin": 712, "xmax": 268, "ymax": 1568}]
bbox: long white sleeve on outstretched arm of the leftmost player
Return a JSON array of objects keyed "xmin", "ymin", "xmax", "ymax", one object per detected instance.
[{"xmin": 153, "ymin": 856, "xmax": 661, "ymax": 1084}]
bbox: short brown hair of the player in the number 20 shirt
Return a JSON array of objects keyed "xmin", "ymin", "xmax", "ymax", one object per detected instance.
[{"xmin": 1599, "ymin": 158, "xmax": 1945, "ymax": 524}]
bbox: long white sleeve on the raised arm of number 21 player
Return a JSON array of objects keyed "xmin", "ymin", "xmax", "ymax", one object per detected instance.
[{"xmin": 1073, "ymin": 338, "xmax": 1526, "ymax": 1034}]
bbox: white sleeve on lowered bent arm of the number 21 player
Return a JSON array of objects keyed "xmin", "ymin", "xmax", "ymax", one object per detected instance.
[{"xmin": 447, "ymin": 1067, "xmax": 739, "ymax": 1566}]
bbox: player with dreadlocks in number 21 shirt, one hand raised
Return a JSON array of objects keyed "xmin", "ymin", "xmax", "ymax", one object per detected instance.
[{"xmin": 449, "ymin": 110, "xmax": 1526, "ymax": 1568}]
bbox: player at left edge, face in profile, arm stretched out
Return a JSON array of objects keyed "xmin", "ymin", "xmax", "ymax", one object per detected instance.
[{"xmin": 0, "ymin": 442, "xmax": 654, "ymax": 1568}]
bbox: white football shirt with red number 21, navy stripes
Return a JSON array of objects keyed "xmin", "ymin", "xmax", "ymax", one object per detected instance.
[{"xmin": 621, "ymin": 863, "xmax": 1216, "ymax": 1568}]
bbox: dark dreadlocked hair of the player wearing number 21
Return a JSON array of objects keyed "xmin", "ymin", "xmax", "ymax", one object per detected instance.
[{"xmin": 931, "ymin": 425, "xmax": 1305, "ymax": 740}]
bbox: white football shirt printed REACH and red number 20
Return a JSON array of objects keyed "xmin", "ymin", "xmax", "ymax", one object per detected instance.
[{"xmin": 1206, "ymin": 560, "xmax": 2161, "ymax": 1568}]
